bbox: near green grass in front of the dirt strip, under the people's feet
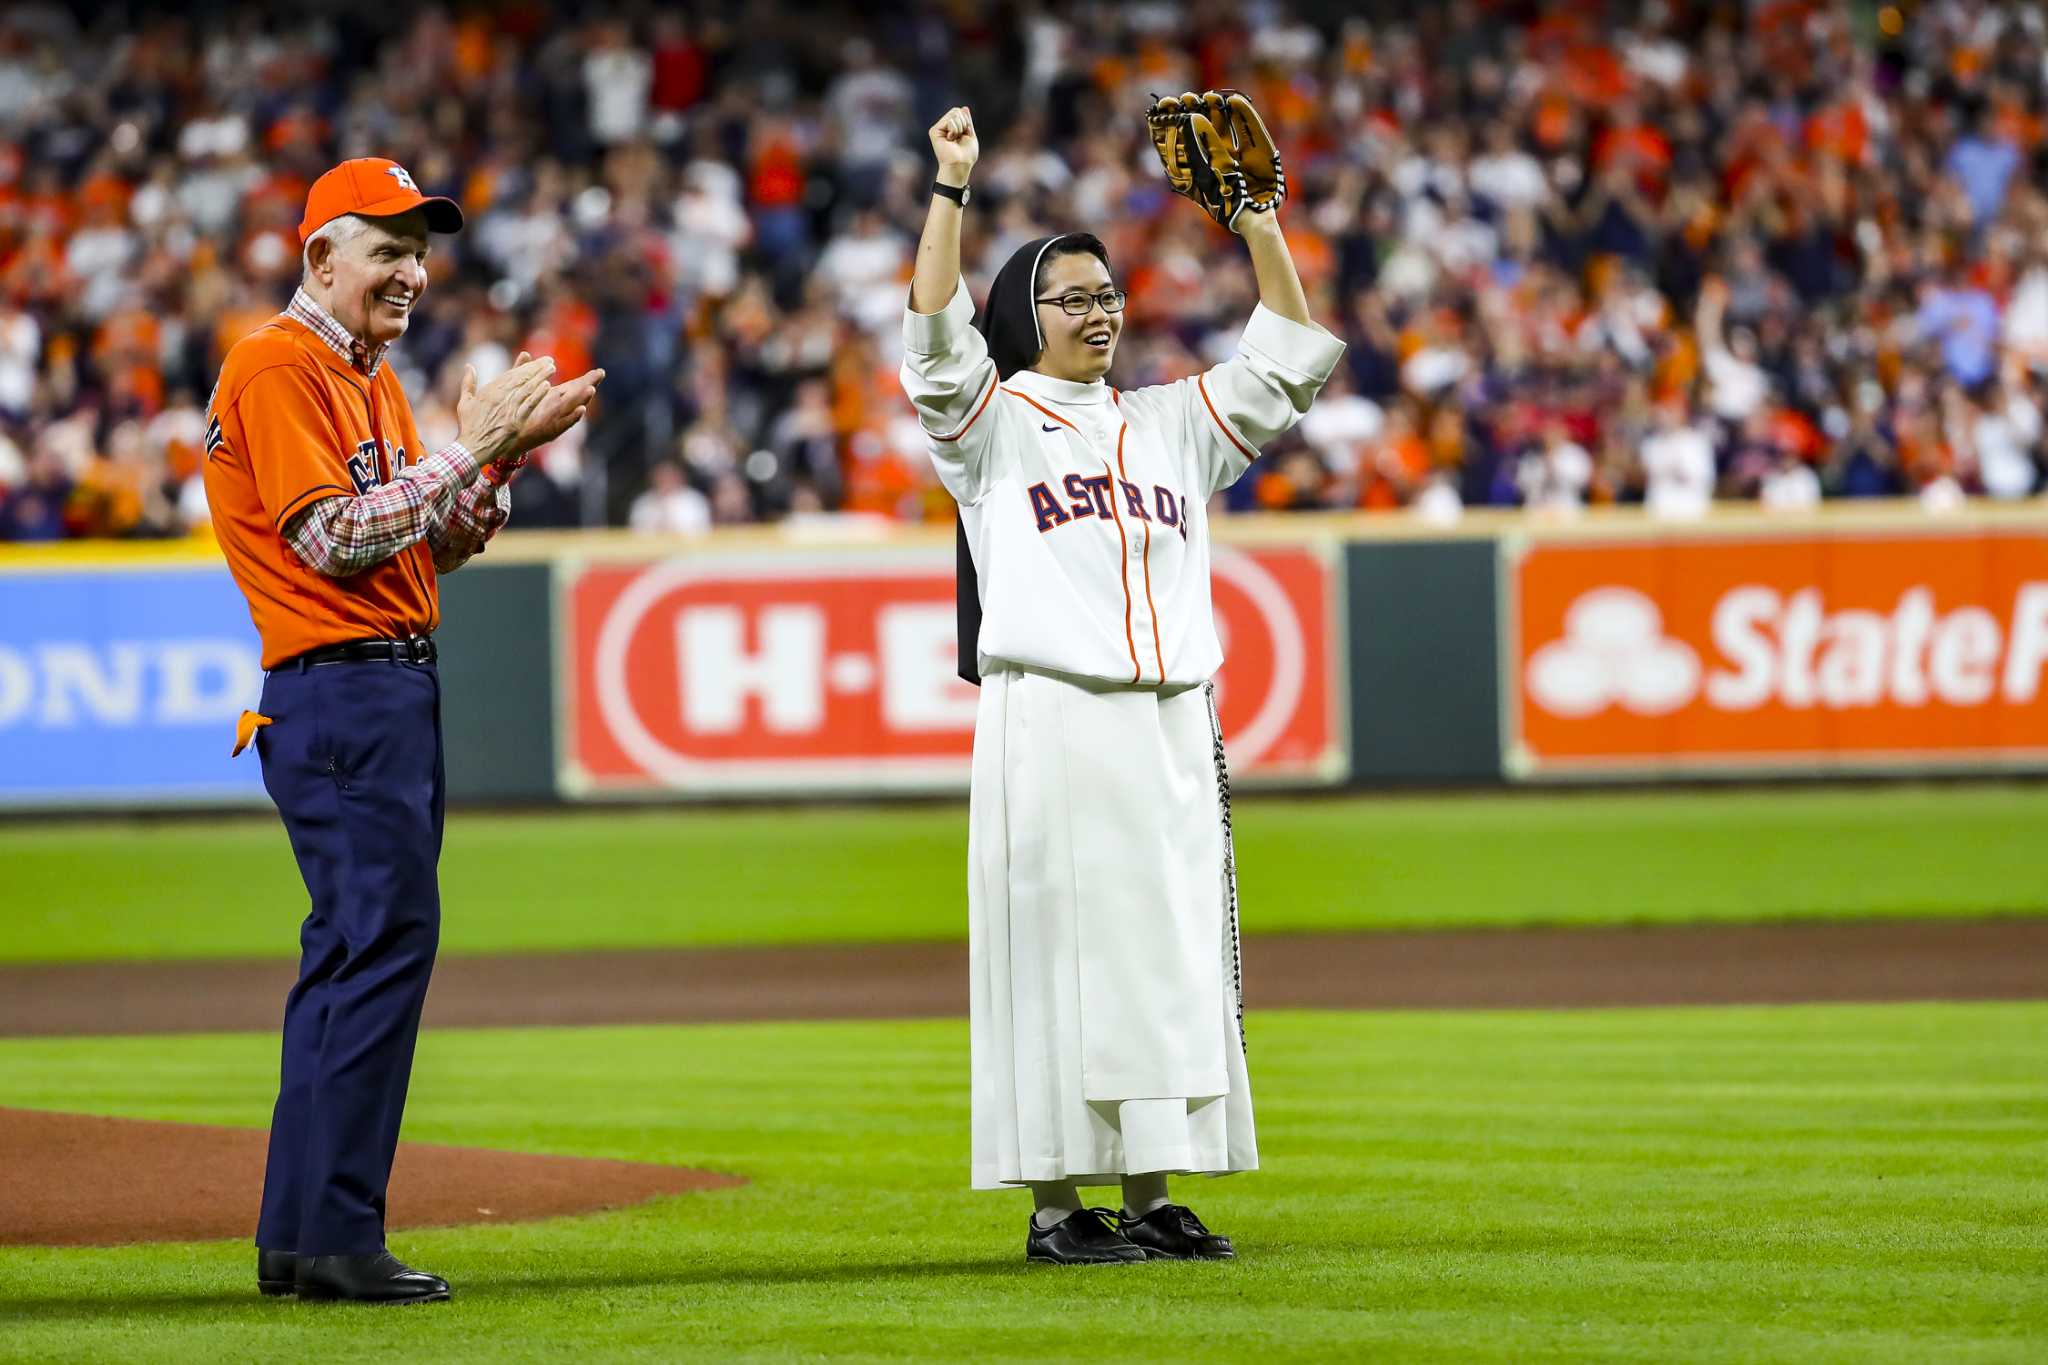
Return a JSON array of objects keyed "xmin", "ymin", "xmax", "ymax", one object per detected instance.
[{"xmin": 0, "ymin": 1005, "xmax": 2048, "ymax": 1361}]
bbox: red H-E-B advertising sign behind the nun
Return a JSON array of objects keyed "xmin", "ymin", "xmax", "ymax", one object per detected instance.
[{"xmin": 563, "ymin": 551, "xmax": 1335, "ymax": 796}]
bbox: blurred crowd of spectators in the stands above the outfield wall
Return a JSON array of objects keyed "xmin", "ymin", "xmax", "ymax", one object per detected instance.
[{"xmin": 0, "ymin": 0, "xmax": 2048, "ymax": 540}]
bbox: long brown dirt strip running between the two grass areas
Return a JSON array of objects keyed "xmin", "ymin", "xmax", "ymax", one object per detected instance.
[{"xmin": 0, "ymin": 917, "xmax": 2048, "ymax": 1038}]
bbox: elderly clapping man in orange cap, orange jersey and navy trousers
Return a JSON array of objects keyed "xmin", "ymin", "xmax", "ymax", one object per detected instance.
[{"xmin": 205, "ymin": 158, "xmax": 604, "ymax": 1304}]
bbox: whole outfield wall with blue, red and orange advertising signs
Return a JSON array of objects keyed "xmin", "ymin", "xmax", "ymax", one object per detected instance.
[{"xmin": 0, "ymin": 505, "xmax": 2048, "ymax": 808}]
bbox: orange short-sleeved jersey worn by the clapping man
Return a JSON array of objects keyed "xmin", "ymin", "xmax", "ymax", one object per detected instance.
[{"xmin": 207, "ymin": 315, "xmax": 440, "ymax": 669}]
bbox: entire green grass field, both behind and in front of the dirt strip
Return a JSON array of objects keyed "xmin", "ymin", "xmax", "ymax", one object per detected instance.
[{"xmin": 0, "ymin": 784, "xmax": 2048, "ymax": 1363}]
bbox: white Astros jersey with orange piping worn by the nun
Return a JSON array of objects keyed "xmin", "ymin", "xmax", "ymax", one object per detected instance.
[{"xmin": 903, "ymin": 280, "xmax": 1343, "ymax": 686}]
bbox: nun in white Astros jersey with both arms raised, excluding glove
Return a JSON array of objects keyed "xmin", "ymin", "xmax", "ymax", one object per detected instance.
[{"xmin": 901, "ymin": 106, "xmax": 1343, "ymax": 1265}]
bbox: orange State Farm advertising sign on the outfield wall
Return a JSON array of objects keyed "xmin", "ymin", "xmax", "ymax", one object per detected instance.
[{"xmin": 1511, "ymin": 532, "xmax": 2048, "ymax": 772}]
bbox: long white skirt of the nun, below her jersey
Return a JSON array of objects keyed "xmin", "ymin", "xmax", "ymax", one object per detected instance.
[{"xmin": 967, "ymin": 665, "xmax": 1260, "ymax": 1189}]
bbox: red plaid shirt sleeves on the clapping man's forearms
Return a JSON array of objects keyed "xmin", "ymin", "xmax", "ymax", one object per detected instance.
[{"xmin": 285, "ymin": 440, "xmax": 510, "ymax": 579}]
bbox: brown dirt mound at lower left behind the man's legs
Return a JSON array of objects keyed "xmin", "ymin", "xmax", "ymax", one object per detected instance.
[{"xmin": 0, "ymin": 1109, "xmax": 745, "ymax": 1246}]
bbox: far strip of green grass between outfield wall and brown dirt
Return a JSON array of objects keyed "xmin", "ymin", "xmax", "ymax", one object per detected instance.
[{"xmin": 0, "ymin": 784, "xmax": 2048, "ymax": 962}]
